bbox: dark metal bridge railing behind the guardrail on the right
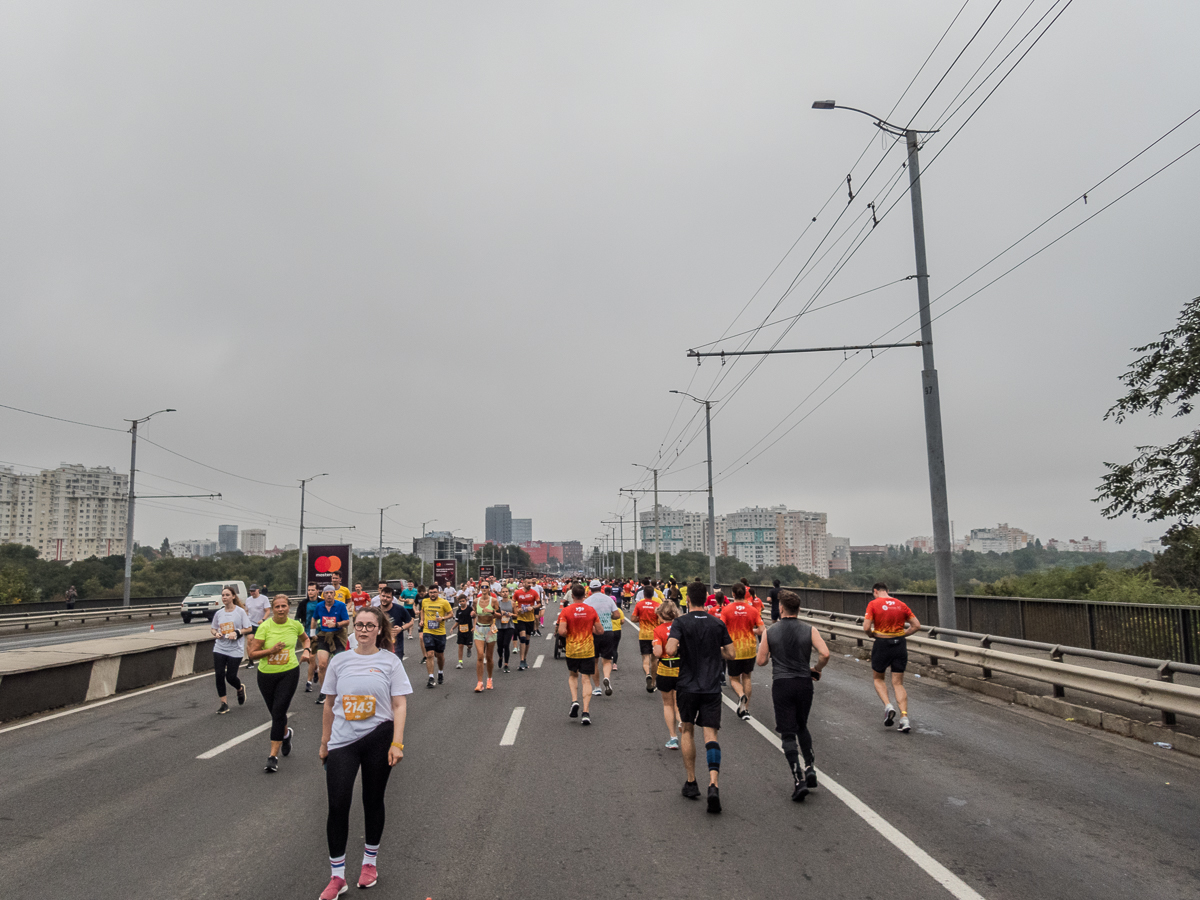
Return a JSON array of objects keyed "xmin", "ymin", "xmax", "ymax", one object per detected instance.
[{"xmin": 755, "ymin": 584, "xmax": 1200, "ymax": 664}]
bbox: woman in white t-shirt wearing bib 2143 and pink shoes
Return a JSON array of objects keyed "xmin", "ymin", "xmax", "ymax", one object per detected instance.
[{"xmin": 320, "ymin": 606, "xmax": 413, "ymax": 900}]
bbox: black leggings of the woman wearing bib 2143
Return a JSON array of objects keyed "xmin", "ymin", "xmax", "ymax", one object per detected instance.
[{"xmin": 325, "ymin": 719, "xmax": 395, "ymax": 859}]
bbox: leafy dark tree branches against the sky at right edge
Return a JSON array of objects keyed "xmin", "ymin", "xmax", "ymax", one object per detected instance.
[{"xmin": 1096, "ymin": 296, "xmax": 1200, "ymax": 524}]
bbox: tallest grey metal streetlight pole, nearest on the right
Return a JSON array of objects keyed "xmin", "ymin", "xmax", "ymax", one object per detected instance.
[{"xmin": 812, "ymin": 100, "xmax": 958, "ymax": 629}]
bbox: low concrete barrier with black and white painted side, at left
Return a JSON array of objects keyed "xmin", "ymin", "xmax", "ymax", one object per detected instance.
[{"xmin": 0, "ymin": 623, "xmax": 215, "ymax": 721}]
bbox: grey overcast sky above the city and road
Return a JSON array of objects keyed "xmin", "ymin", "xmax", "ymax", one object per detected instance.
[{"xmin": 0, "ymin": 0, "xmax": 1200, "ymax": 548}]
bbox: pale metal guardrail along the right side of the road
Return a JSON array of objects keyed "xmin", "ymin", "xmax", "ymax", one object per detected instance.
[{"xmin": 802, "ymin": 610, "xmax": 1200, "ymax": 725}]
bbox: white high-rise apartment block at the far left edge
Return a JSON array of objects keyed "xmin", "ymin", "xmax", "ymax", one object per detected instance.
[{"xmin": 0, "ymin": 463, "xmax": 130, "ymax": 562}]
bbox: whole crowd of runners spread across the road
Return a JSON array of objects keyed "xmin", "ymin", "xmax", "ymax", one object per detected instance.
[{"xmin": 211, "ymin": 574, "xmax": 920, "ymax": 900}]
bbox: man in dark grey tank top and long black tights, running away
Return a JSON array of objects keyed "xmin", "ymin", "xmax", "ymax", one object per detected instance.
[{"xmin": 756, "ymin": 590, "xmax": 829, "ymax": 803}]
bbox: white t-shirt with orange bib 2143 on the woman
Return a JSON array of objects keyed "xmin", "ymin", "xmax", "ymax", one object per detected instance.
[{"xmin": 322, "ymin": 650, "xmax": 413, "ymax": 750}]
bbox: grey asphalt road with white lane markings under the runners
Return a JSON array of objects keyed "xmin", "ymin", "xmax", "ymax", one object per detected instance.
[{"xmin": 0, "ymin": 607, "xmax": 1200, "ymax": 900}]
